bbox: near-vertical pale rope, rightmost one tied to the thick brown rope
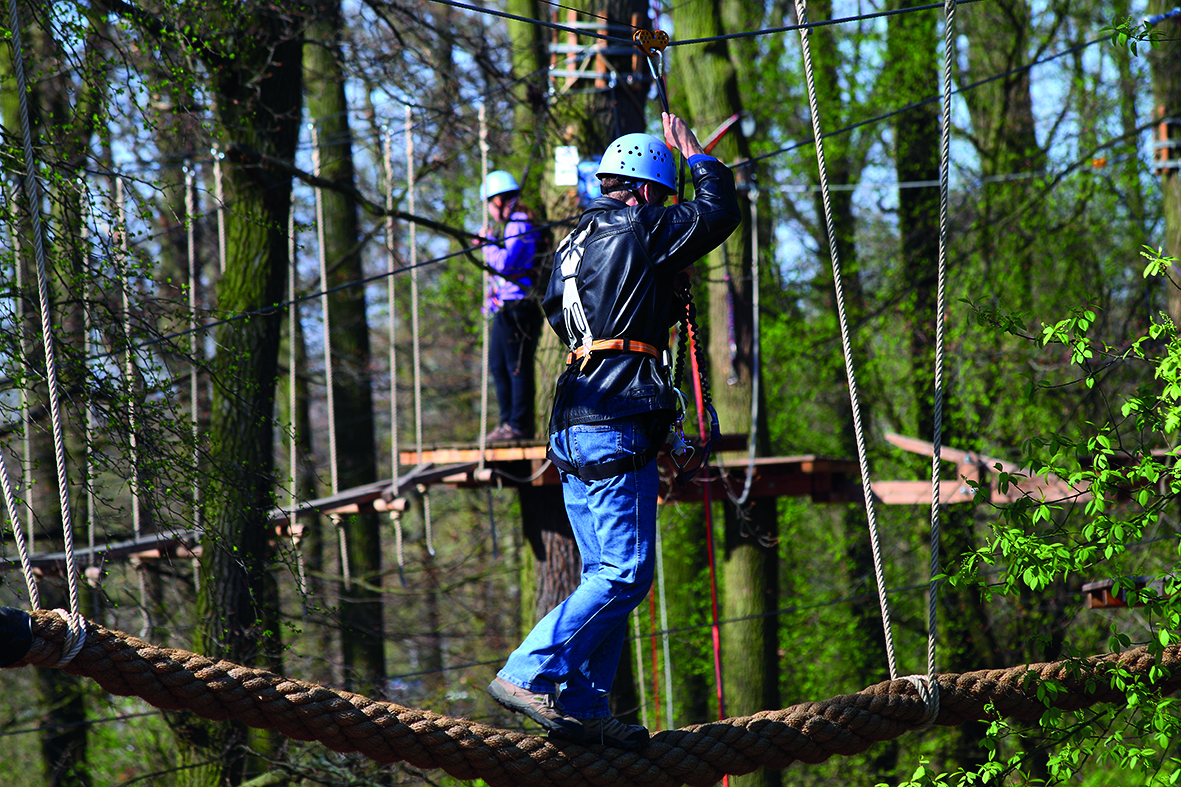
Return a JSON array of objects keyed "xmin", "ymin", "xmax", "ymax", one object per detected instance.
[{"xmin": 927, "ymin": 0, "xmax": 955, "ymax": 718}]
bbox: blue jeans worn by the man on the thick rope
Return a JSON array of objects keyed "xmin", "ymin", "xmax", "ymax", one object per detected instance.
[{"xmin": 498, "ymin": 419, "xmax": 659, "ymax": 718}]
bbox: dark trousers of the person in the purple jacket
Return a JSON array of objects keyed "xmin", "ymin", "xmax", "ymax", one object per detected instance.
[{"xmin": 488, "ymin": 300, "xmax": 542, "ymax": 436}]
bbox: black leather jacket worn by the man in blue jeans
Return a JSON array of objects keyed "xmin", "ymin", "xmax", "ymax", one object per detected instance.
[{"xmin": 542, "ymin": 156, "xmax": 742, "ymax": 434}]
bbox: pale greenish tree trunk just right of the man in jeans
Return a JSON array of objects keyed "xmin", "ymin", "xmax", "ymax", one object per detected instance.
[{"xmin": 677, "ymin": 0, "xmax": 781, "ymax": 786}]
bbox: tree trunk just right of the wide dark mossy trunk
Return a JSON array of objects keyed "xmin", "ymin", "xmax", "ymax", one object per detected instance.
[{"xmin": 304, "ymin": 0, "xmax": 385, "ymax": 694}]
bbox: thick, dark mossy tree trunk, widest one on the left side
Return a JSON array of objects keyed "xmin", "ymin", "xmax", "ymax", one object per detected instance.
[{"xmin": 171, "ymin": 8, "xmax": 302, "ymax": 787}]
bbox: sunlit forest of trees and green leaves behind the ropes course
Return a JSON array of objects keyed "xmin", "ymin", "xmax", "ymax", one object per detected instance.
[{"xmin": 0, "ymin": 0, "xmax": 1181, "ymax": 785}]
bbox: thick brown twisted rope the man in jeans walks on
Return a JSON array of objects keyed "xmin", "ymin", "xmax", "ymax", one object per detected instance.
[{"xmin": 0, "ymin": 609, "xmax": 1181, "ymax": 787}]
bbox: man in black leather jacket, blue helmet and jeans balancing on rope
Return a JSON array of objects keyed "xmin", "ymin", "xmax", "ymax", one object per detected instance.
[{"xmin": 489, "ymin": 113, "xmax": 740, "ymax": 749}]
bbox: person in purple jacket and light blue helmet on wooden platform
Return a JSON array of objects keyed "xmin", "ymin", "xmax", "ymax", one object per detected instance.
[{"xmin": 479, "ymin": 170, "xmax": 542, "ymax": 442}]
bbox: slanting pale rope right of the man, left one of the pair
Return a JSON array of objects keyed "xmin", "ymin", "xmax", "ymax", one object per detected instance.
[{"xmin": 796, "ymin": 0, "xmax": 898, "ymax": 679}]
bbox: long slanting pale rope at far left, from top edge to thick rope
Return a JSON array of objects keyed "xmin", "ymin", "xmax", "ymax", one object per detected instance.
[{"xmin": 8, "ymin": 0, "xmax": 85, "ymax": 636}]
